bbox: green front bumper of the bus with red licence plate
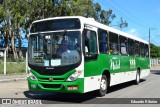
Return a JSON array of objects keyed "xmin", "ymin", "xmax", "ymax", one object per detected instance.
[{"xmin": 27, "ymin": 77, "xmax": 84, "ymax": 93}]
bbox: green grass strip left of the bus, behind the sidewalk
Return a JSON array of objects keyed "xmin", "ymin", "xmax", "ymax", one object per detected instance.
[{"xmin": 0, "ymin": 62, "xmax": 26, "ymax": 74}]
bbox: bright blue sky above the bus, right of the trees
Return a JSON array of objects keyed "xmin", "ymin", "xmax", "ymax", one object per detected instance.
[{"xmin": 94, "ymin": 0, "xmax": 160, "ymax": 46}]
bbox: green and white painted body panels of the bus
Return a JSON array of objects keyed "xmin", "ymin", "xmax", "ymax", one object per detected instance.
[{"xmin": 27, "ymin": 17, "xmax": 150, "ymax": 93}]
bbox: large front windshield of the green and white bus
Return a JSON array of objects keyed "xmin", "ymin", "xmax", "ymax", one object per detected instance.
[{"xmin": 29, "ymin": 31, "xmax": 80, "ymax": 66}]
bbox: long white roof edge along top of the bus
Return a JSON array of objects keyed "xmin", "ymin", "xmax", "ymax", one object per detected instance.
[{"xmin": 33, "ymin": 16, "xmax": 149, "ymax": 44}]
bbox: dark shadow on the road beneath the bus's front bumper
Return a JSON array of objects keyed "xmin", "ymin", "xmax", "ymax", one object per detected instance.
[{"xmin": 24, "ymin": 91, "xmax": 97, "ymax": 104}]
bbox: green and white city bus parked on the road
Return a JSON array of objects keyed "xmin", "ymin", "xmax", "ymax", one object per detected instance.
[{"xmin": 27, "ymin": 16, "xmax": 150, "ymax": 96}]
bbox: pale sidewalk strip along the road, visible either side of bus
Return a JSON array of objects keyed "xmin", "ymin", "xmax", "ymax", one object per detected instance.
[{"xmin": 0, "ymin": 65, "xmax": 160, "ymax": 83}]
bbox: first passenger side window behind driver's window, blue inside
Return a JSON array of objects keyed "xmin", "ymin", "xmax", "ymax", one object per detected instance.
[{"xmin": 98, "ymin": 29, "xmax": 108, "ymax": 54}]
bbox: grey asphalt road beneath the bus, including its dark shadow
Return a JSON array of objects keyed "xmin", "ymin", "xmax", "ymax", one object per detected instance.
[{"xmin": 0, "ymin": 70, "xmax": 160, "ymax": 104}]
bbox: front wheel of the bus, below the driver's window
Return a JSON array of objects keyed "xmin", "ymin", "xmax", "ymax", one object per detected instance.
[{"xmin": 98, "ymin": 75, "xmax": 108, "ymax": 97}]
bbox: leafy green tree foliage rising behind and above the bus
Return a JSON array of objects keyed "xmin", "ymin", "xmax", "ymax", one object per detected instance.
[{"xmin": 0, "ymin": 0, "xmax": 127, "ymax": 48}]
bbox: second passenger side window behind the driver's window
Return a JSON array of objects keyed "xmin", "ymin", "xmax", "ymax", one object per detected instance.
[{"xmin": 109, "ymin": 32, "xmax": 119, "ymax": 54}]
